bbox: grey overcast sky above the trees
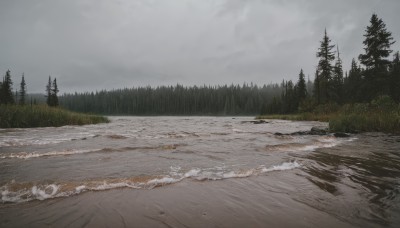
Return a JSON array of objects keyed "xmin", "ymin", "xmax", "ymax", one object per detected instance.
[{"xmin": 0, "ymin": 0, "xmax": 400, "ymax": 93}]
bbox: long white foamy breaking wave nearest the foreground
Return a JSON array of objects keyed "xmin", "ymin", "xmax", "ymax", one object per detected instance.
[{"xmin": 0, "ymin": 161, "xmax": 301, "ymax": 203}]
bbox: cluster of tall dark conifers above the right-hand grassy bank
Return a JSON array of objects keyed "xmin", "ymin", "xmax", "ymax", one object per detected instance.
[{"xmin": 262, "ymin": 15, "xmax": 400, "ymax": 122}]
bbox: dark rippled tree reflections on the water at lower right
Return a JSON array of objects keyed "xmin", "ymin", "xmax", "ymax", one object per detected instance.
[{"xmin": 303, "ymin": 135, "xmax": 400, "ymax": 225}]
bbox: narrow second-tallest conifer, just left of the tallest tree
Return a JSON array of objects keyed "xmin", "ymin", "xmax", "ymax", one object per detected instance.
[{"xmin": 317, "ymin": 29, "xmax": 335, "ymax": 103}]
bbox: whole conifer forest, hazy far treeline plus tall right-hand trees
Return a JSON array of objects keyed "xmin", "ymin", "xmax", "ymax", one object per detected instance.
[{"xmin": 60, "ymin": 14, "xmax": 400, "ymax": 115}]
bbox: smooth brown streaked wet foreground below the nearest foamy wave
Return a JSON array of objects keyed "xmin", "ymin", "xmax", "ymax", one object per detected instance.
[{"xmin": 0, "ymin": 173, "xmax": 351, "ymax": 227}]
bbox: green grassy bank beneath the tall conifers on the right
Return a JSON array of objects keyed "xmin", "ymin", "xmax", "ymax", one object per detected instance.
[{"xmin": 257, "ymin": 97, "xmax": 400, "ymax": 134}]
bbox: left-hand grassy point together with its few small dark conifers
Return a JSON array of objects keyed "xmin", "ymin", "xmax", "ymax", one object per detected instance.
[{"xmin": 0, "ymin": 70, "xmax": 108, "ymax": 128}]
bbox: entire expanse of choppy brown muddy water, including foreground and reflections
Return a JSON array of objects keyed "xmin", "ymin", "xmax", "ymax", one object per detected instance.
[{"xmin": 0, "ymin": 117, "xmax": 400, "ymax": 227}]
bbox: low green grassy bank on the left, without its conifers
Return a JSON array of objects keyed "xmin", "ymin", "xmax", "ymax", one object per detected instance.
[{"xmin": 0, "ymin": 105, "xmax": 109, "ymax": 128}]
